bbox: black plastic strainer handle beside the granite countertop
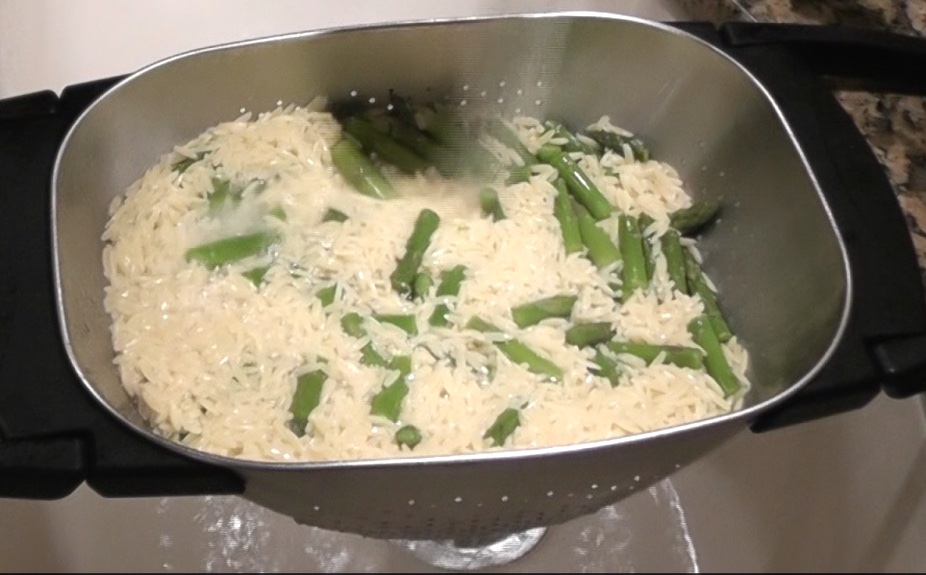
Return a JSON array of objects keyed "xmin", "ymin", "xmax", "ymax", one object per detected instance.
[{"xmin": 719, "ymin": 22, "xmax": 926, "ymax": 431}]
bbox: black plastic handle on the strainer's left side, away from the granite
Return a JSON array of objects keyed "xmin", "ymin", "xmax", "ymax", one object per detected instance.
[{"xmin": 0, "ymin": 79, "xmax": 243, "ymax": 499}]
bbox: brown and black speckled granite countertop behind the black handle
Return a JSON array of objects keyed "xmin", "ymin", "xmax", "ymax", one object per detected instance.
[{"xmin": 683, "ymin": 0, "xmax": 926, "ymax": 283}]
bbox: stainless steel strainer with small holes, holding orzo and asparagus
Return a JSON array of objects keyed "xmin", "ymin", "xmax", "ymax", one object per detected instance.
[{"xmin": 53, "ymin": 13, "xmax": 876, "ymax": 540}]
